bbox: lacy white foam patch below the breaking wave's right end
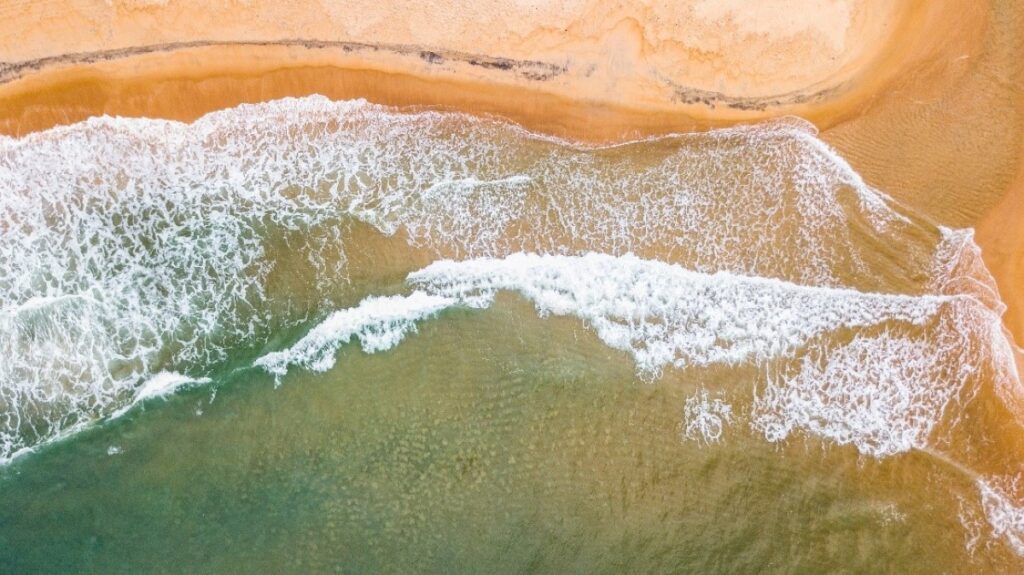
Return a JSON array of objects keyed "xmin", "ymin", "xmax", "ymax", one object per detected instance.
[{"xmin": 752, "ymin": 329, "xmax": 976, "ymax": 457}]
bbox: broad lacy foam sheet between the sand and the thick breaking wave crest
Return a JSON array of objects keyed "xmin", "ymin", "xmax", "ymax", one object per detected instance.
[{"xmin": 0, "ymin": 96, "xmax": 958, "ymax": 458}]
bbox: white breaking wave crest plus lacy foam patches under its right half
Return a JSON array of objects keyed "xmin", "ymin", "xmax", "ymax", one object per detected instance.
[{"xmin": 257, "ymin": 254, "xmax": 1012, "ymax": 457}]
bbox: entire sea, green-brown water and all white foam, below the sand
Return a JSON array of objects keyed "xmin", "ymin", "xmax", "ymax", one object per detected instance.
[{"xmin": 0, "ymin": 97, "xmax": 1024, "ymax": 573}]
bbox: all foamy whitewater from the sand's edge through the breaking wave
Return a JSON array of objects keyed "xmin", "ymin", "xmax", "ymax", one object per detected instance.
[{"xmin": 0, "ymin": 97, "xmax": 1024, "ymax": 555}]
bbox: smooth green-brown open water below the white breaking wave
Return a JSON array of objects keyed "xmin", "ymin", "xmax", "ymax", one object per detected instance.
[{"xmin": 0, "ymin": 297, "xmax": 1009, "ymax": 573}]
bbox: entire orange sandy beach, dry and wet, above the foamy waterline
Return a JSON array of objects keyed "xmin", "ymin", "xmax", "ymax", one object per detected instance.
[{"xmin": 0, "ymin": 0, "xmax": 1024, "ymax": 342}]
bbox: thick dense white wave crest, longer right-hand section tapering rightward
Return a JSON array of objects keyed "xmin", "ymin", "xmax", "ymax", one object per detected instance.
[{"xmin": 409, "ymin": 254, "xmax": 953, "ymax": 374}]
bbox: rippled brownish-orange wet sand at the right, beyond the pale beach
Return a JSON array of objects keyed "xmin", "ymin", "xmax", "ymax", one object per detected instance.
[{"xmin": 822, "ymin": 0, "xmax": 1024, "ymax": 345}]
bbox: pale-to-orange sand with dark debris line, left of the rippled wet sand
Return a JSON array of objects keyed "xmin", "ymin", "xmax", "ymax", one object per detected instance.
[{"xmin": 0, "ymin": 0, "xmax": 958, "ymax": 141}]
